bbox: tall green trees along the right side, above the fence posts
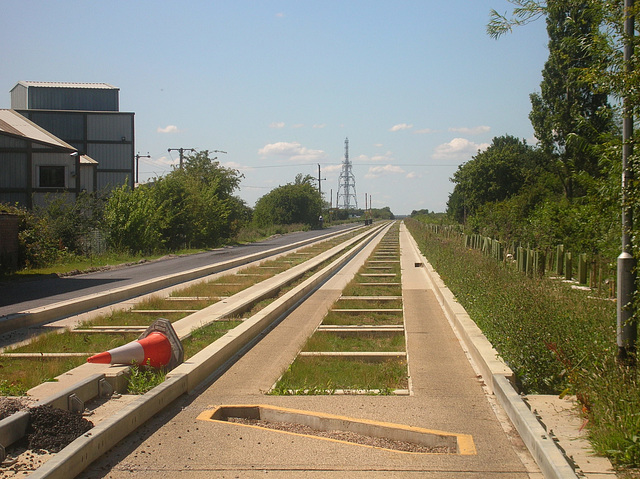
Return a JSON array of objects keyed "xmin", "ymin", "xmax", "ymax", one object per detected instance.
[{"xmin": 447, "ymin": 0, "xmax": 640, "ymax": 270}]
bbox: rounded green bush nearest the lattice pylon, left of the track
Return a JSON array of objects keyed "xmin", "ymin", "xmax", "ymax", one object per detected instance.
[{"xmin": 253, "ymin": 174, "xmax": 322, "ymax": 227}]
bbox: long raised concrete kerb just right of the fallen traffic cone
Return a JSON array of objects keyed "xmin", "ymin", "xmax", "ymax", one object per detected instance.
[{"xmin": 23, "ymin": 223, "xmax": 390, "ymax": 479}]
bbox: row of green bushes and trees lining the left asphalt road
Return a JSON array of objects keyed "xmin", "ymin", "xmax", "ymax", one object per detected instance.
[{"xmin": 0, "ymin": 150, "xmax": 392, "ymax": 269}]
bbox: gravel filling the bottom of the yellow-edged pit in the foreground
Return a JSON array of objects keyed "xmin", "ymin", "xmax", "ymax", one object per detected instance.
[{"xmin": 227, "ymin": 417, "xmax": 456, "ymax": 454}]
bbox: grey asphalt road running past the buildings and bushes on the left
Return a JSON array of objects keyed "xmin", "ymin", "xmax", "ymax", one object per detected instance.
[{"xmin": 0, "ymin": 225, "xmax": 352, "ymax": 316}]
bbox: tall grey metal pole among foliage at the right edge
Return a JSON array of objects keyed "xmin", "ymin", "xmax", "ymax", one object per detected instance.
[{"xmin": 616, "ymin": 0, "xmax": 638, "ymax": 365}]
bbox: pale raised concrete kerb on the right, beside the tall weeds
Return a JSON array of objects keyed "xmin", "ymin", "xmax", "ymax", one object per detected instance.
[{"xmin": 402, "ymin": 225, "xmax": 578, "ymax": 479}]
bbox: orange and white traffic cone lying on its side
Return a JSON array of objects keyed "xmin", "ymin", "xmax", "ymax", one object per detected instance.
[{"xmin": 87, "ymin": 319, "xmax": 184, "ymax": 369}]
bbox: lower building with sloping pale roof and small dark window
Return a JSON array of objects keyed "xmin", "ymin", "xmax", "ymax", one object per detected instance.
[{"xmin": 0, "ymin": 110, "xmax": 97, "ymax": 208}]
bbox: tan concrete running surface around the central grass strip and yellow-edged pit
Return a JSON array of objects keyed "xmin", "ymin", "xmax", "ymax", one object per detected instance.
[{"xmin": 67, "ymin": 225, "xmax": 575, "ymax": 479}]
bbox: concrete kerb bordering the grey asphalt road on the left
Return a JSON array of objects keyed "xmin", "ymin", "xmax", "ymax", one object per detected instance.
[{"xmin": 0, "ymin": 225, "xmax": 360, "ymax": 334}]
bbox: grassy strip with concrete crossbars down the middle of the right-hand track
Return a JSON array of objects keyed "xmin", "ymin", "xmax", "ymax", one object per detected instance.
[{"xmin": 271, "ymin": 223, "xmax": 408, "ymax": 395}]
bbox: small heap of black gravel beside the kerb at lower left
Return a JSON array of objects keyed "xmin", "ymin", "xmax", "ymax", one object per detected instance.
[{"xmin": 27, "ymin": 406, "xmax": 93, "ymax": 452}]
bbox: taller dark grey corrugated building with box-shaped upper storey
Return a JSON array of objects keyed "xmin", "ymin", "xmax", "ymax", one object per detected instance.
[{"xmin": 11, "ymin": 81, "xmax": 135, "ymax": 193}]
